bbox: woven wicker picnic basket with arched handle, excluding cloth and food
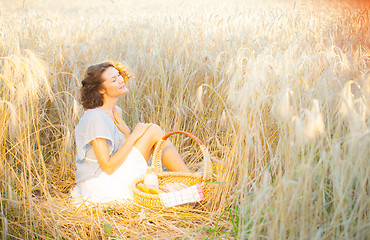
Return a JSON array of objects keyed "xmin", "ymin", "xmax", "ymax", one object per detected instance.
[{"xmin": 131, "ymin": 131, "xmax": 212, "ymax": 208}]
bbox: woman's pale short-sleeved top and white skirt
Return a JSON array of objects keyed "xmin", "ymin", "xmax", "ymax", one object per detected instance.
[{"xmin": 71, "ymin": 108, "xmax": 148, "ymax": 203}]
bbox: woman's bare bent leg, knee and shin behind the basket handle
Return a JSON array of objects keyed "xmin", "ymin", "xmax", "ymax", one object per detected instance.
[{"xmin": 135, "ymin": 124, "xmax": 190, "ymax": 172}]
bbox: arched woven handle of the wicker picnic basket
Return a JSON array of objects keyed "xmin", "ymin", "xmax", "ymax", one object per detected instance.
[{"xmin": 152, "ymin": 131, "xmax": 212, "ymax": 181}]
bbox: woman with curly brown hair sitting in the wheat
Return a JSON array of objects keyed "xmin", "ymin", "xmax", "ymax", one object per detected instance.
[{"xmin": 72, "ymin": 62, "xmax": 189, "ymax": 202}]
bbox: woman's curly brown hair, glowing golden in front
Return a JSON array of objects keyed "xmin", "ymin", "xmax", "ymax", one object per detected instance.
[{"xmin": 80, "ymin": 62, "xmax": 132, "ymax": 110}]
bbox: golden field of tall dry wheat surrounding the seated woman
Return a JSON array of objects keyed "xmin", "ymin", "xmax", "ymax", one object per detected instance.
[{"xmin": 0, "ymin": 0, "xmax": 370, "ymax": 239}]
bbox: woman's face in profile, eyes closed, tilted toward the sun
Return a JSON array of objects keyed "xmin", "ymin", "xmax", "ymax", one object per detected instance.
[{"xmin": 100, "ymin": 67, "xmax": 128, "ymax": 97}]
